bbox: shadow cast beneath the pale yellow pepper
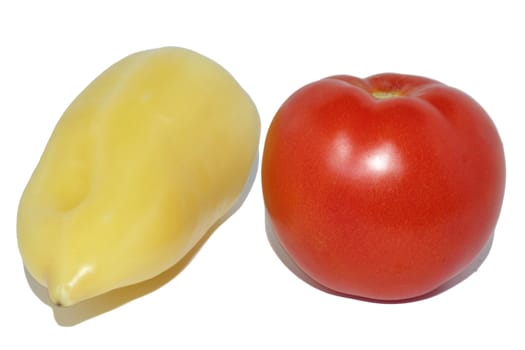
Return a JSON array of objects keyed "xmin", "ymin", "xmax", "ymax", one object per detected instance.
[{"xmin": 25, "ymin": 153, "xmax": 259, "ymax": 326}]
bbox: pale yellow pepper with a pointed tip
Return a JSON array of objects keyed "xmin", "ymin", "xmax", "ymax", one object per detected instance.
[{"xmin": 17, "ymin": 47, "xmax": 260, "ymax": 306}]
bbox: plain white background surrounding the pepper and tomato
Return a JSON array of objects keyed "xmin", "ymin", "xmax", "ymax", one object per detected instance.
[{"xmin": 0, "ymin": 0, "xmax": 525, "ymax": 350}]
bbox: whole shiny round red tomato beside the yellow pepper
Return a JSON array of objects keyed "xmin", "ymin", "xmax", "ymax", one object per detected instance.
[{"xmin": 262, "ymin": 73, "xmax": 505, "ymax": 300}]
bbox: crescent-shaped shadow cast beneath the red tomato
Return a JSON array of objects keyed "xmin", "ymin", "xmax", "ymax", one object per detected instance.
[{"xmin": 265, "ymin": 212, "xmax": 494, "ymax": 304}]
